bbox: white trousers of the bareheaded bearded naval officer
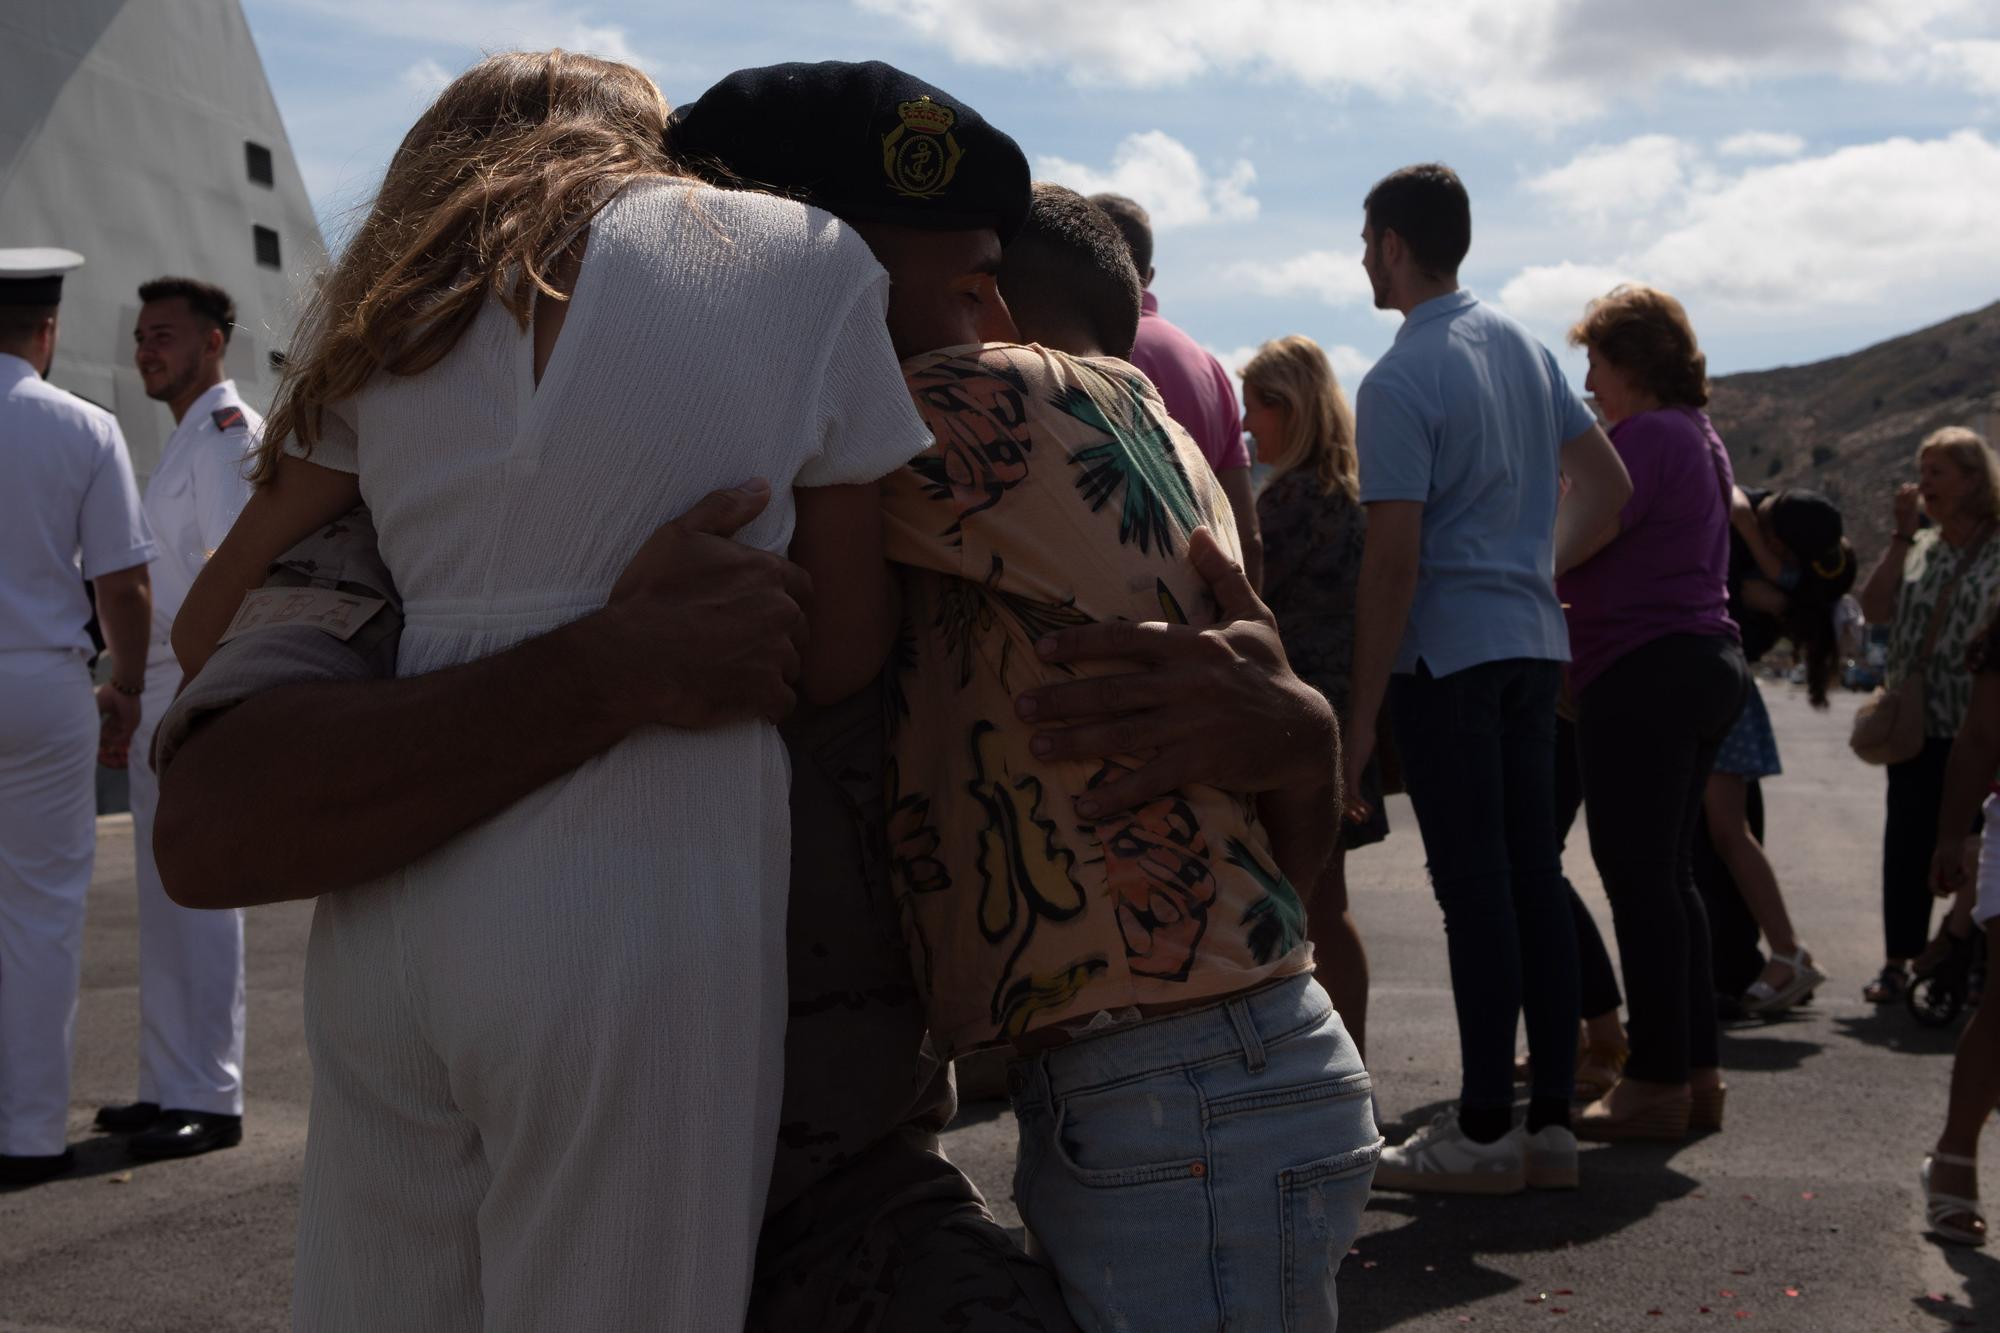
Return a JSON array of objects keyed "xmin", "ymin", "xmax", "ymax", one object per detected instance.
[{"xmin": 128, "ymin": 644, "xmax": 244, "ymax": 1115}]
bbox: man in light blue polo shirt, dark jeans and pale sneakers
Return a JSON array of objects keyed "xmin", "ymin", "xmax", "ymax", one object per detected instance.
[{"xmin": 1346, "ymin": 164, "xmax": 1632, "ymax": 1193}]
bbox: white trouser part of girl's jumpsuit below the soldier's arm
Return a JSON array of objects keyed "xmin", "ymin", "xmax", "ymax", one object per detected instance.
[{"xmin": 292, "ymin": 735, "xmax": 788, "ymax": 1333}]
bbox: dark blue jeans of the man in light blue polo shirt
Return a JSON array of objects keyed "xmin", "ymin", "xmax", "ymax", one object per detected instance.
[{"xmin": 1388, "ymin": 658, "xmax": 1580, "ymax": 1111}]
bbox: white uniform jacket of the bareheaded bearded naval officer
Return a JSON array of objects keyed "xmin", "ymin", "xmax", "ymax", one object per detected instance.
[{"xmin": 146, "ymin": 380, "xmax": 264, "ymax": 644}]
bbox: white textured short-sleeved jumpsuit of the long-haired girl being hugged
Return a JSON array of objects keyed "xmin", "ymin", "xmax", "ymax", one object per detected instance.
[{"xmin": 294, "ymin": 182, "xmax": 928, "ymax": 1329}]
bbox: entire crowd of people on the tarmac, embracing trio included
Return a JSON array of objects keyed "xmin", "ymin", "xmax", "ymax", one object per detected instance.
[{"xmin": 0, "ymin": 52, "xmax": 2000, "ymax": 1329}]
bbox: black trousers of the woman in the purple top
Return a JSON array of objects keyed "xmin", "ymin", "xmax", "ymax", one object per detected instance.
[{"xmin": 1576, "ymin": 634, "xmax": 1750, "ymax": 1083}]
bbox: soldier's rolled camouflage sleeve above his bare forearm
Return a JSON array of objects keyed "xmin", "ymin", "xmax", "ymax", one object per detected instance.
[{"xmin": 152, "ymin": 506, "xmax": 402, "ymax": 775}]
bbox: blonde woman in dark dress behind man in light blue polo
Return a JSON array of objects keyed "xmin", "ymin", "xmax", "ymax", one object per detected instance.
[{"xmin": 1242, "ymin": 334, "xmax": 1388, "ymax": 1055}]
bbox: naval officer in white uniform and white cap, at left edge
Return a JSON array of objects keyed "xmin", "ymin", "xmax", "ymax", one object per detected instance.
[{"xmin": 0, "ymin": 250, "xmax": 164, "ymax": 1185}]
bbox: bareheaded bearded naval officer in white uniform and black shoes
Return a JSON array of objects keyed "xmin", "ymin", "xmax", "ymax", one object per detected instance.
[{"xmin": 98, "ymin": 278, "xmax": 264, "ymax": 1157}]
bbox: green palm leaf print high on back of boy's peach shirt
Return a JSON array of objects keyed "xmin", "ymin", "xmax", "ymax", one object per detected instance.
[{"xmin": 1050, "ymin": 374, "xmax": 1200, "ymax": 554}]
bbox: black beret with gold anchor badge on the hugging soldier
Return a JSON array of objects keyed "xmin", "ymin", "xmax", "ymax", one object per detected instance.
[{"xmin": 666, "ymin": 60, "xmax": 1030, "ymax": 242}]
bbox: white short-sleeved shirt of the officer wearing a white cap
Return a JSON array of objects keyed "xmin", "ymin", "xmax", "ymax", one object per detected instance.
[{"xmin": 0, "ymin": 352, "xmax": 154, "ymax": 652}]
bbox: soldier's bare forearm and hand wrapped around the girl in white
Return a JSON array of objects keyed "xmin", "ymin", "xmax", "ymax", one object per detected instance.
[{"xmin": 154, "ymin": 484, "xmax": 808, "ymax": 907}]
